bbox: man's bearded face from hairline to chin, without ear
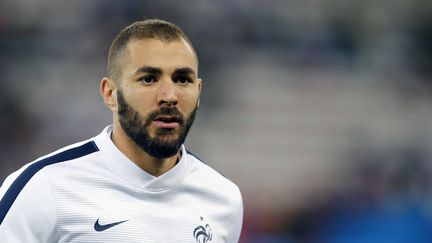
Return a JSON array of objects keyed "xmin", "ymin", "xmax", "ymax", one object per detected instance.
[{"xmin": 117, "ymin": 39, "xmax": 201, "ymax": 158}]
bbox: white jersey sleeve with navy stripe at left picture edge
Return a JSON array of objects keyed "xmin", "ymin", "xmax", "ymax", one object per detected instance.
[{"xmin": 0, "ymin": 168, "xmax": 56, "ymax": 243}]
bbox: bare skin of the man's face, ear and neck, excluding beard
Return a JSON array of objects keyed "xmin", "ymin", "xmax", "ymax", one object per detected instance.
[{"xmin": 100, "ymin": 39, "xmax": 202, "ymax": 176}]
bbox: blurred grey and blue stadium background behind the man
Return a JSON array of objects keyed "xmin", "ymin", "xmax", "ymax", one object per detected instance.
[{"xmin": 0, "ymin": 0, "xmax": 432, "ymax": 243}]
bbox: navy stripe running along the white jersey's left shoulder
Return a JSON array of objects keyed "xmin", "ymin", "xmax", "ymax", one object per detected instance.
[{"xmin": 0, "ymin": 141, "xmax": 99, "ymax": 225}]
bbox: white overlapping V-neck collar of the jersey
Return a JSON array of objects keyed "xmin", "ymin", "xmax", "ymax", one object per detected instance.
[{"xmin": 94, "ymin": 125, "xmax": 189, "ymax": 191}]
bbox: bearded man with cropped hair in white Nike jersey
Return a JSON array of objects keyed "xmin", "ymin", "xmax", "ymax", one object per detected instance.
[{"xmin": 0, "ymin": 20, "xmax": 243, "ymax": 243}]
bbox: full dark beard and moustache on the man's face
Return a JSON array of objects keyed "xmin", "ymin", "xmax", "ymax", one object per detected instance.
[{"xmin": 117, "ymin": 91, "xmax": 198, "ymax": 159}]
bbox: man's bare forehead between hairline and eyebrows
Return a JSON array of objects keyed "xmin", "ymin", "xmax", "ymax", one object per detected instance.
[{"xmin": 125, "ymin": 38, "xmax": 198, "ymax": 72}]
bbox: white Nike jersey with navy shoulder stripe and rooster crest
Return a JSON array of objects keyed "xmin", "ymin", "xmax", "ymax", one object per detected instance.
[{"xmin": 0, "ymin": 126, "xmax": 243, "ymax": 243}]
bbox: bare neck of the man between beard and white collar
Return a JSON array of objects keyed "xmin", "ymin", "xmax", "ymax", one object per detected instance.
[{"xmin": 111, "ymin": 124, "xmax": 180, "ymax": 177}]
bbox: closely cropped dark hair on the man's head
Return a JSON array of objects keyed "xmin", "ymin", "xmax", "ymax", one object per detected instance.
[{"xmin": 107, "ymin": 19, "xmax": 196, "ymax": 82}]
